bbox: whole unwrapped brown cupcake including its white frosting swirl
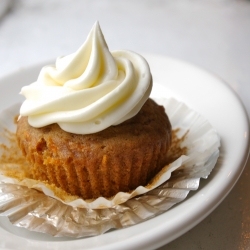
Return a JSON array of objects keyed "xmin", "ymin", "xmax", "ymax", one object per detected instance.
[{"xmin": 16, "ymin": 23, "xmax": 171, "ymax": 199}]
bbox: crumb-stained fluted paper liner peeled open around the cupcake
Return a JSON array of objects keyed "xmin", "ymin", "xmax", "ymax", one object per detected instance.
[{"xmin": 0, "ymin": 98, "xmax": 220, "ymax": 237}]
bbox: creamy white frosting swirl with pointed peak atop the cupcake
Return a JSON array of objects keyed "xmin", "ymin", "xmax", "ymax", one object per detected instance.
[{"xmin": 20, "ymin": 22, "xmax": 152, "ymax": 134}]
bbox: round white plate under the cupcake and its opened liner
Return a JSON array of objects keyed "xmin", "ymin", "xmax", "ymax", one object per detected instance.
[{"xmin": 0, "ymin": 55, "xmax": 249, "ymax": 250}]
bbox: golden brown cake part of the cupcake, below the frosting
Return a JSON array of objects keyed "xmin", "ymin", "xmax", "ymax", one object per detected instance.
[{"xmin": 17, "ymin": 99, "xmax": 171, "ymax": 199}]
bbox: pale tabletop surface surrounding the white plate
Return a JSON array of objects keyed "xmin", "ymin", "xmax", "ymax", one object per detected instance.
[{"xmin": 0, "ymin": 0, "xmax": 250, "ymax": 250}]
